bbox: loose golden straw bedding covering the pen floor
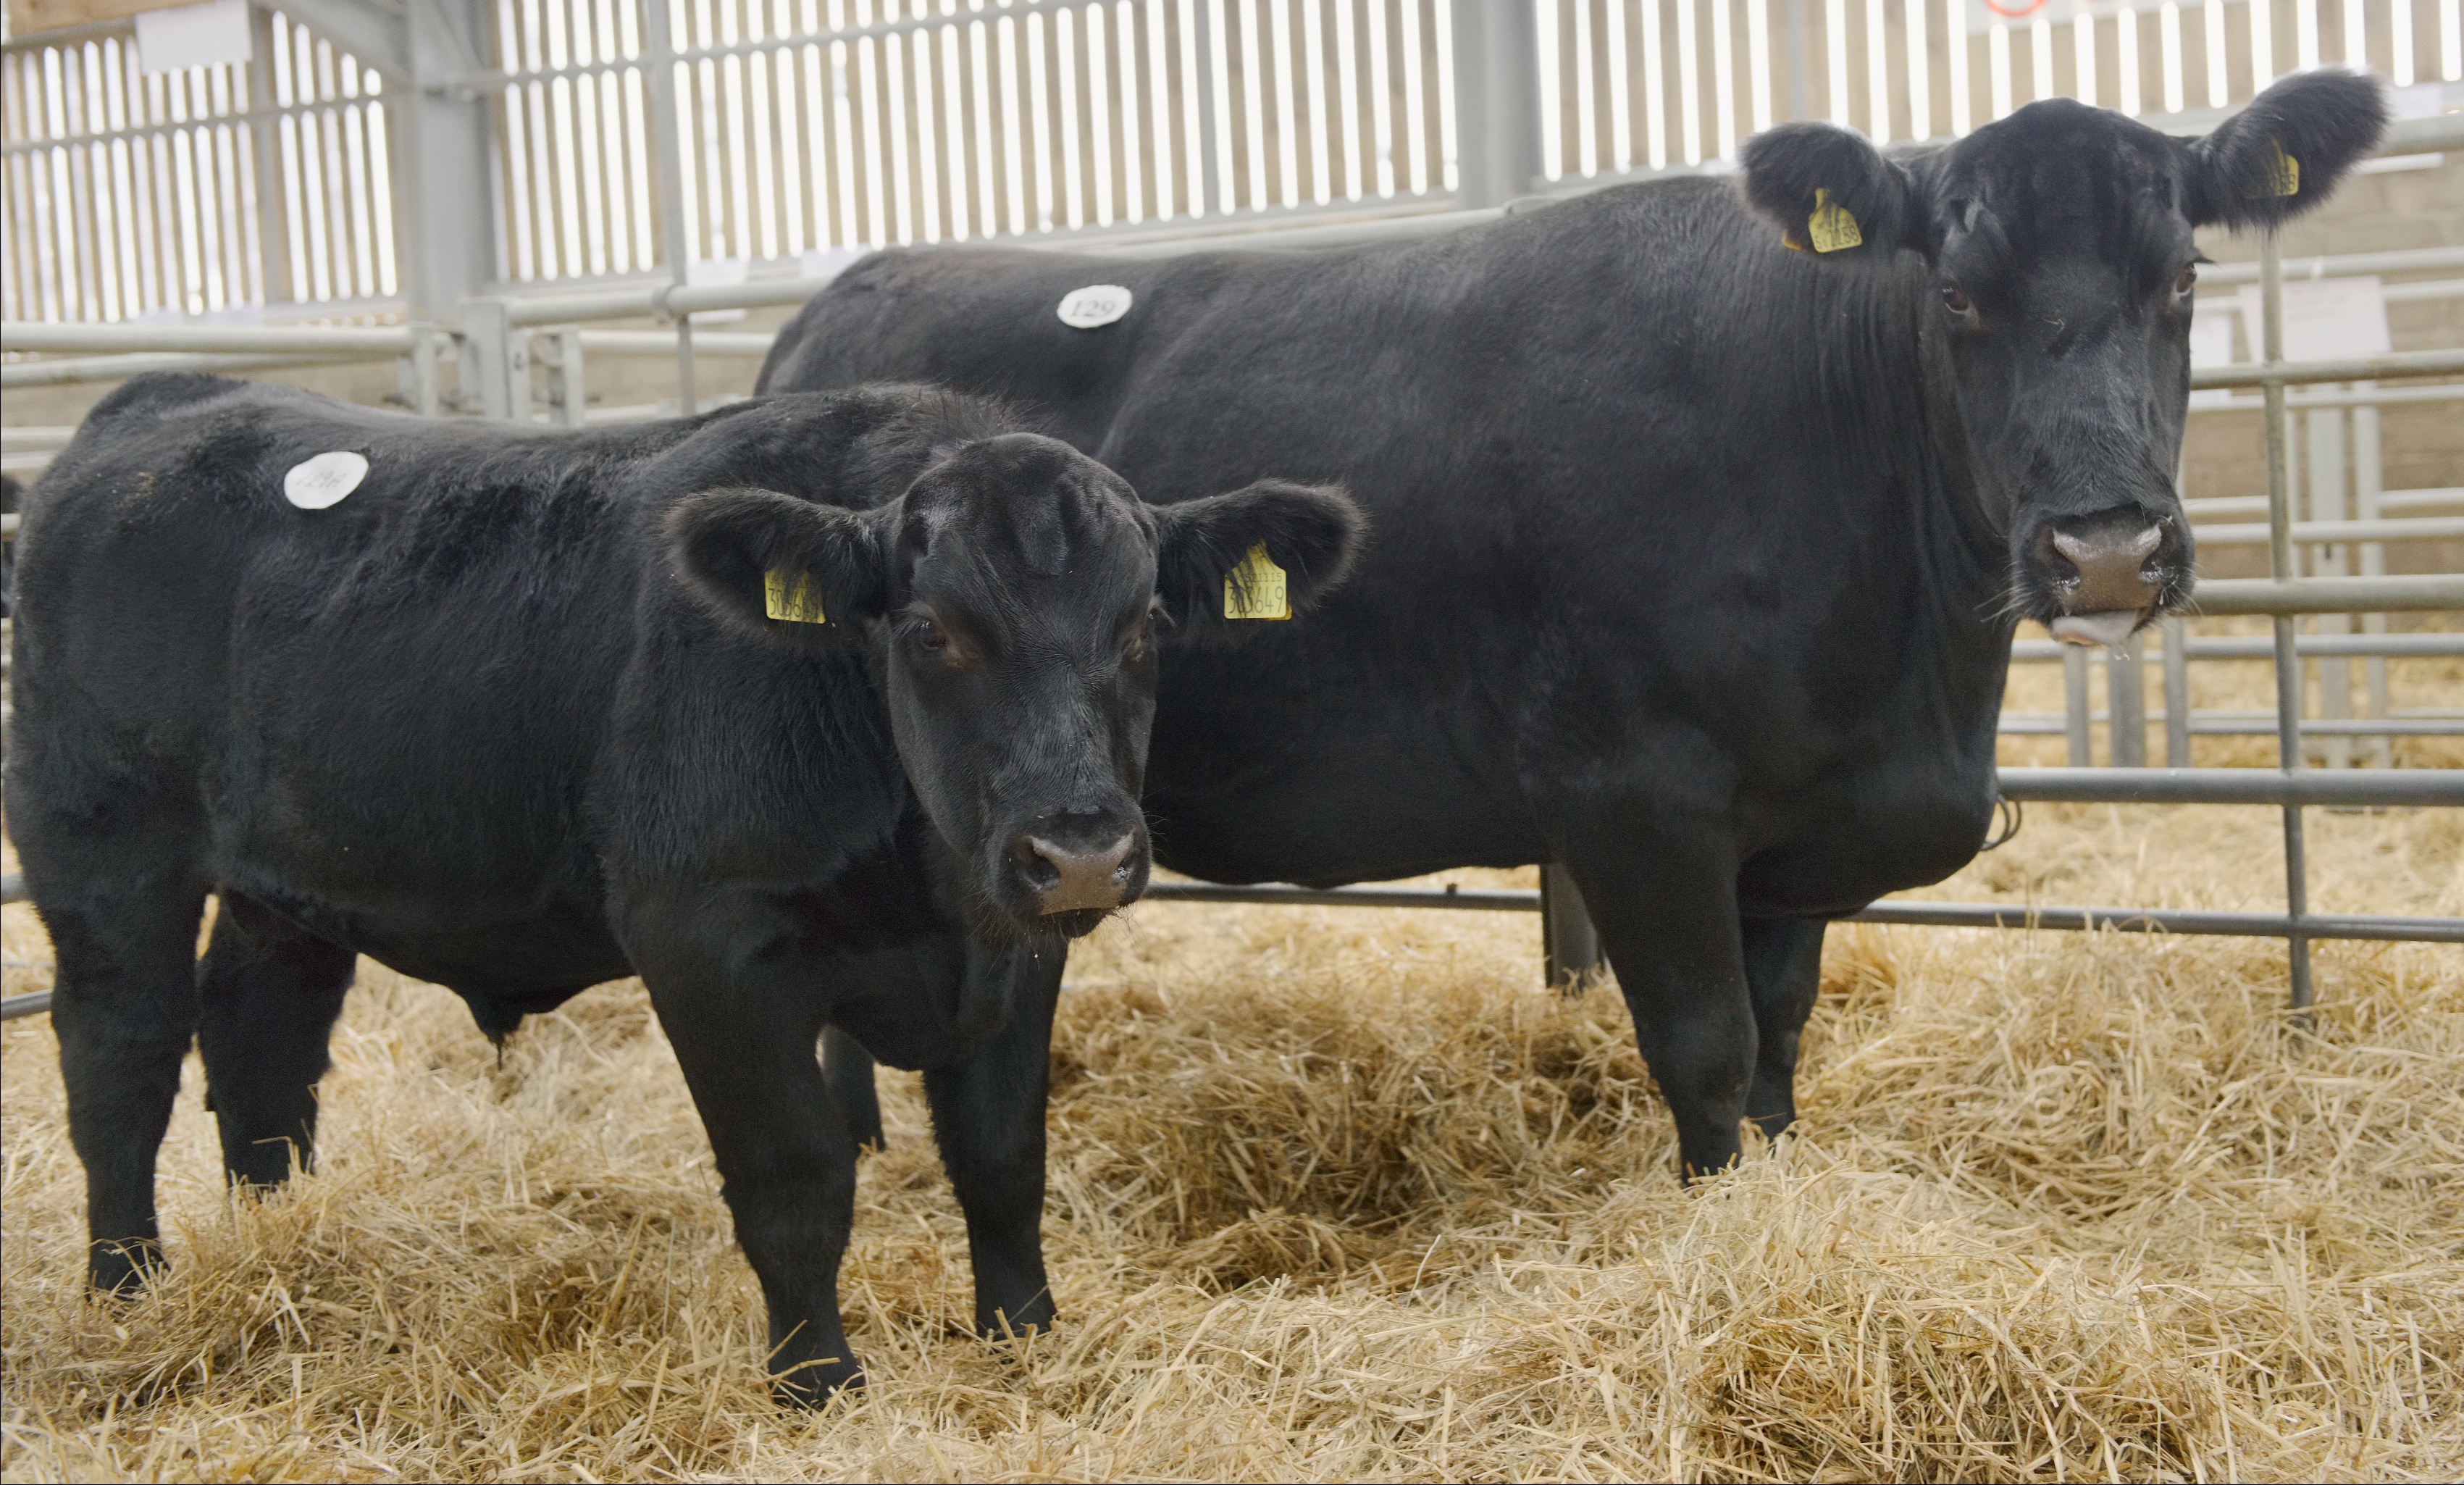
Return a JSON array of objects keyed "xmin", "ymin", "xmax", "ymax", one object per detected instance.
[{"xmin": 0, "ymin": 640, "xmax": 2464, "ymax": 1480}]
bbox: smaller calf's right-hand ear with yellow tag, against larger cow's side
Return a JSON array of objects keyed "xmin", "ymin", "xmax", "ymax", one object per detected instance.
[{"xmin": 1156, "ymin": 480, "xmax": 1370, "ymax": 633}]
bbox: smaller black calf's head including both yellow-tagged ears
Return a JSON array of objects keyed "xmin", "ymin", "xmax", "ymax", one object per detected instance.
[{"xmin": 668, "ymin": 433, "xmax": 1365, "ymax": 936}]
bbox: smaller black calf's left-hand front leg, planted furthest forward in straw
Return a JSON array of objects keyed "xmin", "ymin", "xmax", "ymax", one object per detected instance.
[{"xmin": 626, "ymin": 901, "xmax": 865, "ymax": 1404}]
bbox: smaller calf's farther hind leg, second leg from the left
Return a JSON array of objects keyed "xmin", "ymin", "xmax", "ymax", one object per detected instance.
[{"xmin": 197, "ymin": 894, "xmax": 357, "ymax": 1187}]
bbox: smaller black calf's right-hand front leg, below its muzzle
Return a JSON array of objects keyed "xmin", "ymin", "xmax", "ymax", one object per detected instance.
[{"xmin": 924, "ymin": 938, "xmax": 1067, "ymax": 1337}]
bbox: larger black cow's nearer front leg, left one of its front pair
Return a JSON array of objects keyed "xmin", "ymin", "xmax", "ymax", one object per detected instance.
[{"xmin": 1567, "ymin": 827, "xmax": 1757, "ymax": 1179}]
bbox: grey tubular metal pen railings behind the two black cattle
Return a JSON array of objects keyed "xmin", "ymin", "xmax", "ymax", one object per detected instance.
[{"xmin": 0, "ymin": 116, "xmax": 2464, "ymax": 1019}]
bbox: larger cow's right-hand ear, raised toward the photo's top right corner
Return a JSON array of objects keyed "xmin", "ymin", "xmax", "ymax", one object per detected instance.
[{"xmin": 2188, "ymin": 69, "xmax": 2388, "ymax": 227}]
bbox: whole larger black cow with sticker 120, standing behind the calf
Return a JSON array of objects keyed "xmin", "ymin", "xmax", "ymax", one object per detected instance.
[{"xmin": 761, "ymin": 74, "xmax": 2385, "ymax": 1172}]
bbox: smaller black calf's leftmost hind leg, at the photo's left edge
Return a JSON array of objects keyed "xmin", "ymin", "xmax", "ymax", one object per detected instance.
[{"xmin": 27, "ymin": 866, "xmax": 204, "ymax": 1293}]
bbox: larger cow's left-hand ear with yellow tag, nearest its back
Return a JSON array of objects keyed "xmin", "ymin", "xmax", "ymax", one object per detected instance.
[{"xmin": 1737, "ymin": 121, "xmax": 1927, "ymax": 261}]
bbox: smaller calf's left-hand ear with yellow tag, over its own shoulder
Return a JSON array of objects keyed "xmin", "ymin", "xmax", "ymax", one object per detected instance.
[{"xmin": 668, "ymin": 490, "xmax": 889, "ymax": 638}]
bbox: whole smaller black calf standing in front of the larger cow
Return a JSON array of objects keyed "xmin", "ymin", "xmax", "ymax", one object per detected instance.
[{"xmin": 7, "ymin": 377, "xmax": 1358, "ymax": 1399}]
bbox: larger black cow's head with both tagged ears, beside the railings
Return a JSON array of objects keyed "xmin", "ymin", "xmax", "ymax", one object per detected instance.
[{"xmin": 1742, "ymin": 72, "xmax": 2388, "ymax": 645}]
